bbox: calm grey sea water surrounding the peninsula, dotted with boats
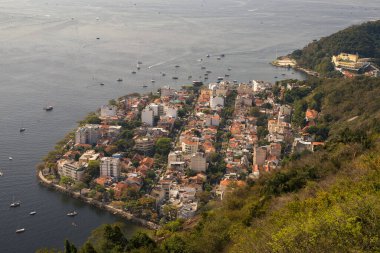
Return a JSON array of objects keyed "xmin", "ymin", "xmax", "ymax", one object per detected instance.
[{"xmin": 0, "ymin": 0, "xmax": 380, "ymax": 252}]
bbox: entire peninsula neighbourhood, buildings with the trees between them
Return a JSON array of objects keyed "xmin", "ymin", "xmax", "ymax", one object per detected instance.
[{"xmin": 43, "ymin": 80, "xmax": 324, "ymax": 223}]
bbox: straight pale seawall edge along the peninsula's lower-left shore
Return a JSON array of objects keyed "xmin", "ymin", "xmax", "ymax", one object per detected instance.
[{"xmin": 37, "ymin": 171, "xmax": 160, "ymax": 230}]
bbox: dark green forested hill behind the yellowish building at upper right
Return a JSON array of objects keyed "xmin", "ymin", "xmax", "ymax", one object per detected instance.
[{"xmin": 290, "ymin": 20, "xmax": 380, "ymax": 74}]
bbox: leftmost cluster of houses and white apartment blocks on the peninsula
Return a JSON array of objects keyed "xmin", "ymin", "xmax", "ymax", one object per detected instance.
[{"xmin": 57, "ymin": 87, "xmax": 191, "ymax": 206}]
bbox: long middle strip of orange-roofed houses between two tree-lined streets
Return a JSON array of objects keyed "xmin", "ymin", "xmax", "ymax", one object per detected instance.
[{"xmin": 152, "ymin": 82, "xmax": 231, "ymax": 218}]
